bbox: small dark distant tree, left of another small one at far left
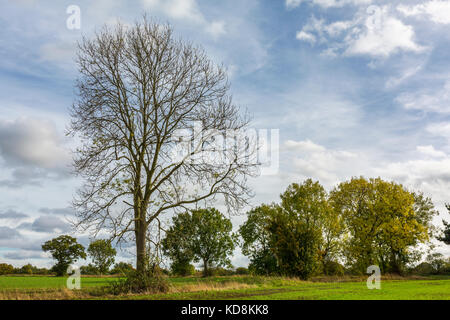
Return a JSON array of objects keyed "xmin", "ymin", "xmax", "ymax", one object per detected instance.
[{"xmin": 42, "ymin": 235, "xmax": 86, "ymax": 276}]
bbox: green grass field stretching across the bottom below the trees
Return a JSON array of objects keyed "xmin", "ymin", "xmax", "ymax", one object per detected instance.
[{"xmin": 0, "ymin": 276, "xmax": 450, "ymax": 300}]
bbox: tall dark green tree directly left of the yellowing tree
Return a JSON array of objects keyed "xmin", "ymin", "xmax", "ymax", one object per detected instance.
[{"xmin": 269, "ymin": 179, "xmax": 343, "ymax": 279}]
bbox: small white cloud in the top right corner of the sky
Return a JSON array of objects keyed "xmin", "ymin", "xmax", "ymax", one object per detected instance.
[{"xmin": 397, "ymin": 0, "xmax": 450, "ymax": 24}]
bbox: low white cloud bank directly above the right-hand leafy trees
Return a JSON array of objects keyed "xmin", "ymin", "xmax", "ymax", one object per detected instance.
[{"xmin": 273, "ymin": 140, "xmax": 450, "ymax": 207}]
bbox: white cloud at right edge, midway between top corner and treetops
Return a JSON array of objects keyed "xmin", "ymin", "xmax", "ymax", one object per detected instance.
[{"xmin": 396, "ymin": 80, "xmax": 450, "ymax": 113}]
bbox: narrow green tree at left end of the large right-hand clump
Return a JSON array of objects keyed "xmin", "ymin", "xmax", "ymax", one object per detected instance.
[{"xmin": 239, "ymin": 205, "xmax": 279, "ymax": 275}]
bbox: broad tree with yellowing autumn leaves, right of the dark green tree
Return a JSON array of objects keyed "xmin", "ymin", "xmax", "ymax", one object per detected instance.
[{"xmin": 330, "ymin": 177, "xmax": 436, "ymax": 273}]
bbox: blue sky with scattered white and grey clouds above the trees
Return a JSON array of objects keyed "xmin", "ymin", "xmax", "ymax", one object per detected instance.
[{"xmin": 0, "ymin": 0, "xmax": 450, "ymax": 267}]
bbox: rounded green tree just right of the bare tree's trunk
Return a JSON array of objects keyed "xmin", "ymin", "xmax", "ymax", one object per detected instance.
[{"xmin": 162, "ymin": 208, "xmax": 237, "ymax": 276}]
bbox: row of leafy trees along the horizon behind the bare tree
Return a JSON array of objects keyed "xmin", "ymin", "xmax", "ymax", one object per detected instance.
[{"xmin": 0, "ymin": 177, "xmax": 450, "ymax": 279}]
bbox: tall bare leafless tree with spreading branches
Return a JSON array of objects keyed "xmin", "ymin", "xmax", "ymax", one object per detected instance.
[{"xmin": 70, "ymin": 17, "xmax": 257, "ymax": 271}]
